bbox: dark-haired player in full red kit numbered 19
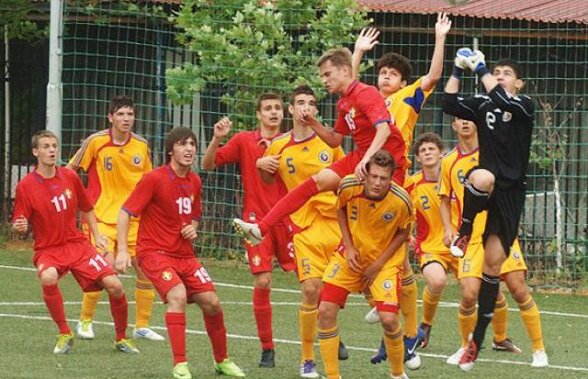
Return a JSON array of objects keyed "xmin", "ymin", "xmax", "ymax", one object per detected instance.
[{"xmin": 115, "ymin": 127, "xmax": 245, "ymax": 379}]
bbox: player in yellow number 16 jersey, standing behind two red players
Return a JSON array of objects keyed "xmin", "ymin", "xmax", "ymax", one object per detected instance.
[{"xmin": 67, "ymin": 95, "xmax": 164, "ymax": 341}]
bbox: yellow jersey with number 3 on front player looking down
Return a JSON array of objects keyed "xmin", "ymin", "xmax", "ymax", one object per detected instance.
[{"xmin": 337, "ymin": 175, "xmax": 414, "ymax": 268}]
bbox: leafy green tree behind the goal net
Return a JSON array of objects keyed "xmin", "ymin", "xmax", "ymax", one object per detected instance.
[{"xmin": 167, "ymin": 0, "xmax": 369, "ymax": 128}]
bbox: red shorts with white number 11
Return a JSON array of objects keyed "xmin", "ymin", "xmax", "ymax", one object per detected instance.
[{"xmin": 33, "ymin": 241, "xmax": 116, "ymax": 292}]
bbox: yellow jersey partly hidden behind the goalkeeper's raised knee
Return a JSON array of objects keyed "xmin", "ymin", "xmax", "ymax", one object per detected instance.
[{"xmin": 439, "ymin": 146, "xmax": 488, "ymax": 244}]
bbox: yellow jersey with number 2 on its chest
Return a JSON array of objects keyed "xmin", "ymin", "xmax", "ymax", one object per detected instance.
[{"xmin": 407, "ymin": 171, "xmax": 455, "ymax": 253}]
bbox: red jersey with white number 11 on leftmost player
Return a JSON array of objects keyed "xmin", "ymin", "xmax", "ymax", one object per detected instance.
[{"xmin": 12, "ymin": 167, "xmax": 93, "ymax": 252}]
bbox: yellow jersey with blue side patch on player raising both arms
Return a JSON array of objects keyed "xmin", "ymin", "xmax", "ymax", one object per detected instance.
[{"xmin": 385, "ymin": 77, "xmax": 434, "ymax": 162}]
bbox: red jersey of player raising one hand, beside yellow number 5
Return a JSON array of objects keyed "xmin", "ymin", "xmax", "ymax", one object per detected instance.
[{"xmin": 214, "ymin": 130, "xmax": 286, "ymax": 221}]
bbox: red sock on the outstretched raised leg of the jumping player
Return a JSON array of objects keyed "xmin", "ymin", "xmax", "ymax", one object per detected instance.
[{"xmin": 259, "ymin": 178, "xmax": 319, "ymax": 235}]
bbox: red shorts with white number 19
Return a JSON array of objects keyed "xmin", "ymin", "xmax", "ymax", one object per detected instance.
[{"xmin": 137, "ymin": 251, "xmax": 216, "ymax": 302}]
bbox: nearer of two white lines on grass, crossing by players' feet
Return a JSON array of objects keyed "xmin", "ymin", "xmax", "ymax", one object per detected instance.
[{"xmin": 0, "ymin": 313, "xmax": 588, "ymax": 372}]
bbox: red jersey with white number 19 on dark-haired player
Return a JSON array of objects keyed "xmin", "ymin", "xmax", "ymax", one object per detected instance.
[{"xmin": 122, "ymin": 165, "xmax": 202, "ymax": 258}]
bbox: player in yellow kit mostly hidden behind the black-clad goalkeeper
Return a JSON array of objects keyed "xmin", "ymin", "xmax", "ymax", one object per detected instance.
[{"xmin": 438, "ymin": 118, "xmax": 548, "ymax": 367}]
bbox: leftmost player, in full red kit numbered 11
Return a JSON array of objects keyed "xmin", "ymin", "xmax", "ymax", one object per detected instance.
[{"xmin": 12, "ymin": 130, "xmax": 139, "ymax": 354}]
